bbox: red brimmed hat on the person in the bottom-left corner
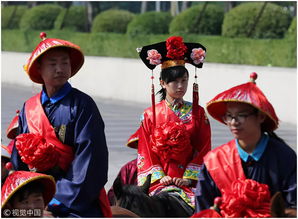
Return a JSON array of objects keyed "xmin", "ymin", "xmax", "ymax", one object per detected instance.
[{"xmin": 1, "ymin": 171, "xmax": 56, "ymax": 208}]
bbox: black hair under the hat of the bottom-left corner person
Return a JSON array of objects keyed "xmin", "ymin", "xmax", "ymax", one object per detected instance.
[{"xmin": 9, "ymin": 181, "xmax": 44, "ymax": 202}]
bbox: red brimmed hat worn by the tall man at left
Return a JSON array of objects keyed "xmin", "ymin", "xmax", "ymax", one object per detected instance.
[{"xmin": 24, "ymin": 32, "xmax": 84, "ymax": 84}]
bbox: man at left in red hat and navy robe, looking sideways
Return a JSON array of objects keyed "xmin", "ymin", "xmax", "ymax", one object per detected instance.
[{"xmin": 12, "ymin": 33, "xmax": 110, "ymax": 217}]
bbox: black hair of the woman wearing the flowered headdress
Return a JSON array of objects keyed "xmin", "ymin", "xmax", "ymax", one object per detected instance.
[{"xmin": 157, "ymin": 66, "xmax": 189, "ymax": 101}]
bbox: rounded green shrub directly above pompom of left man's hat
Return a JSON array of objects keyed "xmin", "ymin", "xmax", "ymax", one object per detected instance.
[{"xmin": 20, "ymin": 4, "xmax": 62, "ymax": 30}]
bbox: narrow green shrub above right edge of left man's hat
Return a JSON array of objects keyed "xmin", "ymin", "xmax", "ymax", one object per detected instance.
[{"xmin": 55, "ymin": 6, "xmax": 88, "ymax": 32}]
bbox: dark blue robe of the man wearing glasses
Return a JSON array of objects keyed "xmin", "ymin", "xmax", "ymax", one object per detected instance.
[{"xmin": 195, "ymin": 137, "xmax": 297, "ymax": 212}]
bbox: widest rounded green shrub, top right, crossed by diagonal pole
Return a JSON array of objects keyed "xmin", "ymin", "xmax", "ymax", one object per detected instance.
[{"xmin": 222, "ymin": 2, "xmax": 291, "ymax": 38}]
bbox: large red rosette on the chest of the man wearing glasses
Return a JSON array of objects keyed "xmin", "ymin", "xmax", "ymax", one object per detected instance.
[{"xmin": 220, "ymin": 179, "xmax": 271, "ymax": 218}]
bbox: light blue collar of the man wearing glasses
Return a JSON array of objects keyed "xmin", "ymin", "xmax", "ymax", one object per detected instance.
[{"xmin": 235, "ymin": 134, "xmax": 269, "ymax": 162}]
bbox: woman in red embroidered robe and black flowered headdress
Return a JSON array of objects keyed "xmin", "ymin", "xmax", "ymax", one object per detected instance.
[{"xmin": 137, "ymin": 37, "xmax": 211, "ymax": 215}]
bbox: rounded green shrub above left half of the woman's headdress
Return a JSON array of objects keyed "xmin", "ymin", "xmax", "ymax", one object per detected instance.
[{"xmin": 127, "ymin": 11, "xmax": 172, "ymax": 36}]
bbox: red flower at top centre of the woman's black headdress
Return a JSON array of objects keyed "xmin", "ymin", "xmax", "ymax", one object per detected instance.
[{"xmin": 166, "ymin": 36, "xmax": 187, "ymax": 60}]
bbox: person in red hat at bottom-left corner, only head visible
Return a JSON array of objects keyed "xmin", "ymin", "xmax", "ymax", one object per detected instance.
[{"xmin": 1, "ymin": 171, "xmax": 55, "ymax": 217}]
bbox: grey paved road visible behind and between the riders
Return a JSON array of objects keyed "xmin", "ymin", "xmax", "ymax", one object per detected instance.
[{"xmin": 1, "ymin": 83, "xmax": 297, "ymax": 189}]
